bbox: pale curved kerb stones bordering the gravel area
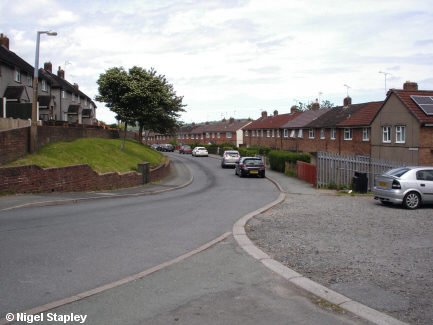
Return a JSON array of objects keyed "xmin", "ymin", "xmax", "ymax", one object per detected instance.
[{"xmin": 232, "ymin": 177, "xmax": 409, "ymax": 325}]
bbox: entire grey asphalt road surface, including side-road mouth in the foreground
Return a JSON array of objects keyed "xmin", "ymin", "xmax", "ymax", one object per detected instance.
[{"xmin": 0, "ymin": 153, "xmax": 369, "ymax": 325}]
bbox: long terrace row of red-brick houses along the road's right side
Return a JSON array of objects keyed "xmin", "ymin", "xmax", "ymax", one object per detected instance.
[{"xmin": 145, "ymin": 82, "xmax": 433, "ymax": 166}]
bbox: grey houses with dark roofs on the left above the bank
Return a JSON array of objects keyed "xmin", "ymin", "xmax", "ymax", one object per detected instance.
[{"xmin": 0, "ymin": 34, "xmax": 96, "ymax": 125}]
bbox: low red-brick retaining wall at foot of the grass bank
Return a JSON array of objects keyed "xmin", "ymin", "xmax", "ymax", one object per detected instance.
[{"xmin": 0, "ymin": 159, "xmax": 170, "ymax": 193}]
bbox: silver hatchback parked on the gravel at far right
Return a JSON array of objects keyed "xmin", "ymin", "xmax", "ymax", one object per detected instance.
[{"xmin": 373, "ymin": 167, "xmax": 433, "ymax": 209}]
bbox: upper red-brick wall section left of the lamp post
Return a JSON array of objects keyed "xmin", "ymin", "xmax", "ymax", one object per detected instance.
[{"xmin": 0, "ymin": 127, "xmax": 30, "ymax": 165}]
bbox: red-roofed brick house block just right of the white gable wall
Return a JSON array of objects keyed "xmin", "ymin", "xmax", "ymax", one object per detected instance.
[{"xmin": 244, "ymin": 107, "xmax": 302, "ymax": 150}]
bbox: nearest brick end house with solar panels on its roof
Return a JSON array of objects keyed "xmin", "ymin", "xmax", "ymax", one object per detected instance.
[{"xmin": 371, "ymin": 81, "xmax": 433, "ymax": 166}]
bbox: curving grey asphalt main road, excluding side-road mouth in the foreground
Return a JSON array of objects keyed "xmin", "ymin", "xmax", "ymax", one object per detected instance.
[{"xmin": 0, "ymin": 153, "xmax": 279, "ymax": 318}]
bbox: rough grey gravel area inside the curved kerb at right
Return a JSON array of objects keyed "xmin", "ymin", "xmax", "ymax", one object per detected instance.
[{"xmin": 246, "ymin": 194, "xmax": 433, "ymax": 325}]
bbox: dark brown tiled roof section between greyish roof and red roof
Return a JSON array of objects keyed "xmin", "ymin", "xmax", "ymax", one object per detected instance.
[{"xmin": 305, "ymin": 103, "xmax": 370, "ymax": 128}]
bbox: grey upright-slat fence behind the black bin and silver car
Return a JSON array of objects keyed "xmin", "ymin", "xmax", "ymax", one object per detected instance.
[{"xmin": 316, "ymin": 151, "xmax": 406, "ymax": 190}]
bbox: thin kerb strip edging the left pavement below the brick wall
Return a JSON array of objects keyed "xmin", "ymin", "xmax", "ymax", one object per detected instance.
[{"xmin": 0, "ymin": 159, "xmax": 194, "ymax": 210}]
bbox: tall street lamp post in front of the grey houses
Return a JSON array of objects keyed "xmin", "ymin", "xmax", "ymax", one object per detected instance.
[{"xmin": 30, "ymin": 30, "xmax": 57, "ymax": 153}]
